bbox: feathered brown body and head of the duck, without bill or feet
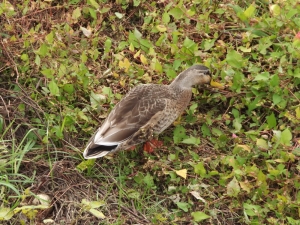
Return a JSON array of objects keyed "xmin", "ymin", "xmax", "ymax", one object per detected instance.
[{"xmin": 83, "ymin": 64, "xmax": 211, "ymax": 159}]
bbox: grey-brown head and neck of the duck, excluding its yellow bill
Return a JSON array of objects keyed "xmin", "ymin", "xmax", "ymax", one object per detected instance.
[{"xmin": 170, "ymin": 65, "xmax": 211, "ymax": 89}]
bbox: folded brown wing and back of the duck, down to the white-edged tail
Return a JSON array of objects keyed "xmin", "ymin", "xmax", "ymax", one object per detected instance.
[{"xmin": 84, "ymin": 85, "xmax": 170, "ymax": 158}]
